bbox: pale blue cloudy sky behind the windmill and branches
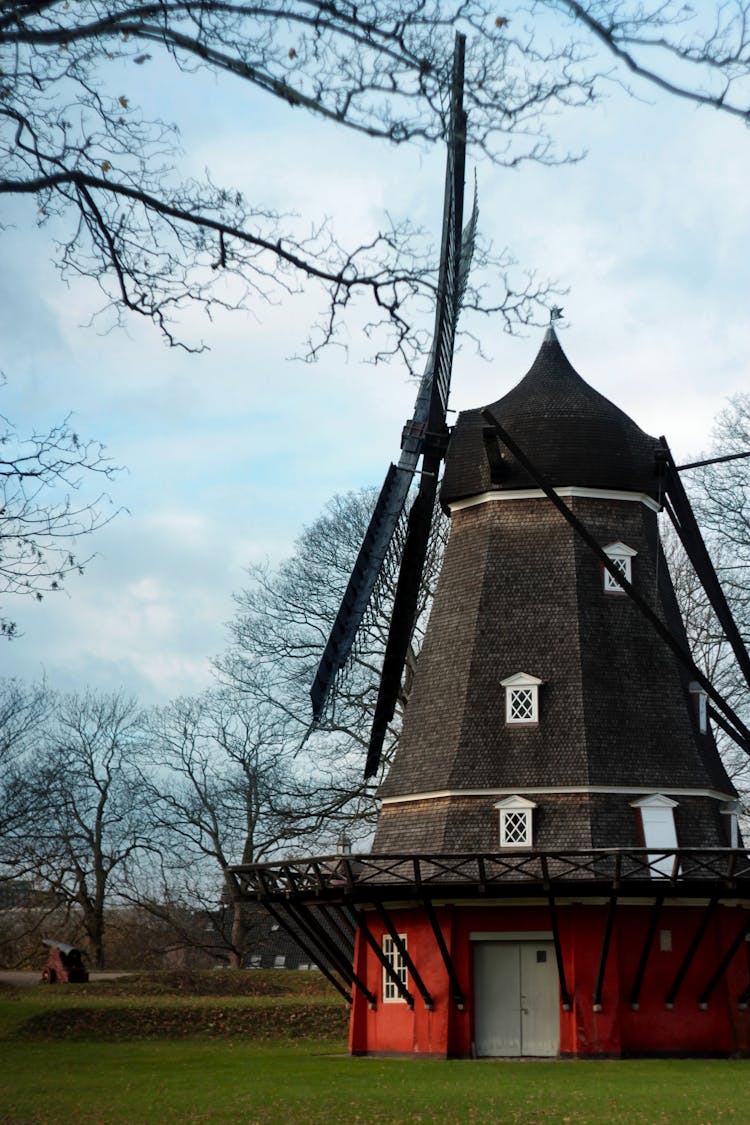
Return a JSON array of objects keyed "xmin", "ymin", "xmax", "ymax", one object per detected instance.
[{"xmin": 0, "ymin": 17, "xmax": 750, "ymax": 705}]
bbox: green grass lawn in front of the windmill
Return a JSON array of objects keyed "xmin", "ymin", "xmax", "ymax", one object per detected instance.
[{"xmin": 0, "ymin": 974, "xmax": 750, "ymax": 1125}]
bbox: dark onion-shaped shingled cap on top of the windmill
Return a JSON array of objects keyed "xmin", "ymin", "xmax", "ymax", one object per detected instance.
[{"xmin": 441, "ymin": 327, "xmax": 658, "ymax": 506}]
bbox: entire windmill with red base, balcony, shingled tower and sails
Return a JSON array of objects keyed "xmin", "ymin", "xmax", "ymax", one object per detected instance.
[{"xmin": 236, "ymin": 41, "xmax": 750, "ymax": 1058}]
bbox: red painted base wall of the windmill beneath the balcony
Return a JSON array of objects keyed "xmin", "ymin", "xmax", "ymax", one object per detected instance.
[{"xmin": 350, "ymin": 902, "xmax": 750, "ymax": 1058}]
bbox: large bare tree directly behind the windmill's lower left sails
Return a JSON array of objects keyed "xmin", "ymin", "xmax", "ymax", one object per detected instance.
[{"xmin": 211, "ymin": 489, "xmax": 448, "ymax": 819}]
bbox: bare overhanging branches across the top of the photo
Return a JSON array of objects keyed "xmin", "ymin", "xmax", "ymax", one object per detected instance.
[{"xmin": 0, "ymin": 0, "xmax": 749, "ymax": 358}]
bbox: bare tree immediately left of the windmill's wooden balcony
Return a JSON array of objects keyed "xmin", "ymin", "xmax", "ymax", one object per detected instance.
[{"xmin": 130, "ymin": 691, "xmax": 320, "ymax": 968}]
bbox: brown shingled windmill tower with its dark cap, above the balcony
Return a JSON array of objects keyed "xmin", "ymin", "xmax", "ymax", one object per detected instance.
[{"xmin": 373, "ymin": 331, "xmax": 733, "ymax": 853}]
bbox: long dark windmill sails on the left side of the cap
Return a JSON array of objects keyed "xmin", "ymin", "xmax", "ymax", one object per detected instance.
[{"xmin": 310, "ymin": 35, "xmax": 477, "ymax": 747}]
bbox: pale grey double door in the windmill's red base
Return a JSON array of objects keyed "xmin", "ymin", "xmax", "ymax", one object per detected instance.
[{"xmin": 475, "ymin": 941, "xmax": 560, "ymax": 1058}]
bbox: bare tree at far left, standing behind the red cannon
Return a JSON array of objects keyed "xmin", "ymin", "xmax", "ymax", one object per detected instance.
[{"xmin": 21, "ymin": 694, "xmax": 151, "ymax": 968}]
